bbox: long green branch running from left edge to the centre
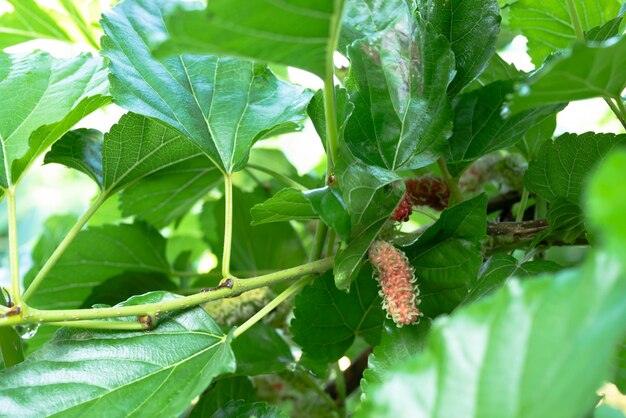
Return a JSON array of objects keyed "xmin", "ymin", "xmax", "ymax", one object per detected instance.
[{"xmin": 0, "ymin": 258, "xmax": 333, "ymax": 326}]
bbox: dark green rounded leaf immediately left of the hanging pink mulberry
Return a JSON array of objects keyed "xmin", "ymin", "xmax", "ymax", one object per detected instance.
[{"xmin": 291, "ymin": 267, "xmax": 384, "ymax": 363}]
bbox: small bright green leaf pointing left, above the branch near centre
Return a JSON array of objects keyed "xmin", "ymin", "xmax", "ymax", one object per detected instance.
[{"xmin": 250, "ymin": 189, "xmax": 317, "ymax": 225}]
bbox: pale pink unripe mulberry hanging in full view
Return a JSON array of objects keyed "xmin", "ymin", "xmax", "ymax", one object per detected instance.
[{"xmin": 368, "ymin": 241, "xmax": 423, "ymax": 327}]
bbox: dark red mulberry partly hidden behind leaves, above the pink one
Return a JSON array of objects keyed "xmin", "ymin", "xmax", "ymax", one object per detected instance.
[{"xmin": 391, "ymin": 175, "xmax": 450, "ymax": 222}]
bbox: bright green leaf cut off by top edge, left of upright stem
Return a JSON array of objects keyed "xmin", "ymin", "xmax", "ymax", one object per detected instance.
[{"xmin": 147, "ymin": 0, "xmax": 343, "ymax": 78}]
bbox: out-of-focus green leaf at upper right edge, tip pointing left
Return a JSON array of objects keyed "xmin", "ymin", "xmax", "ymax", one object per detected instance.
[{"xmin": 510, "ymin": 37, "xmax": 626, "ymax": 113}]
